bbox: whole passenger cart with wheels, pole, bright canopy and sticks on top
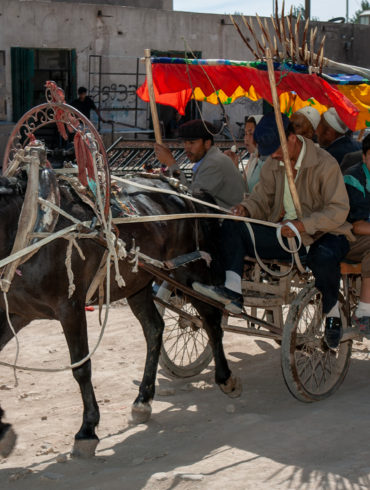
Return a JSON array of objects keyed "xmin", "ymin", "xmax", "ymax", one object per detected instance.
[{"xmin": 134, "ymin": 7, "xmax": 370, "ymax": 402}]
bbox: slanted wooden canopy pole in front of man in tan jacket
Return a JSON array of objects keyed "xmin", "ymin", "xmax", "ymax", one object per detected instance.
[{"xmin": 266, "ymin": 48, "xmax": 302, "ymax": 220}]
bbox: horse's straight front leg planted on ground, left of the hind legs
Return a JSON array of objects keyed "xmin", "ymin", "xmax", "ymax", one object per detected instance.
[{"xmin": 59, "ymin": 301, "xmax": 100, "ymax": 458}]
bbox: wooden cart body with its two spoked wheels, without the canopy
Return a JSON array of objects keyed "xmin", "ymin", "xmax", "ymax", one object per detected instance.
[{"xmin": 155, "ymin": 257, "xmax": 361, "ymax": 402}]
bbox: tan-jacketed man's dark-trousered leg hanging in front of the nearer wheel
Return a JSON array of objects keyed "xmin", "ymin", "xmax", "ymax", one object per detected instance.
[{"xmin": 307, "ymin": 233, "xmax": 349, "ymax": 348}]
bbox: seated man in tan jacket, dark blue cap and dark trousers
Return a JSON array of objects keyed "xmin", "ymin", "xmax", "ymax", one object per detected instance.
[{"xmin": 193, "ymin": 113, "xmax": 353, "ymax": 348}]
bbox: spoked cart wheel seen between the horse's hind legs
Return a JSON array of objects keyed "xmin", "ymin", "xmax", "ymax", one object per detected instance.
[{"xmin": 156, "ymin": 283, "xmax": 213, "ymax": 378}]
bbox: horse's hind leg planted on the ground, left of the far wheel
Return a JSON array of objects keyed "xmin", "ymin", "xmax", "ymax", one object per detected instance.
[{"xmin": 128, "ymin": 283, "xmax": 164, "ymax": 424}]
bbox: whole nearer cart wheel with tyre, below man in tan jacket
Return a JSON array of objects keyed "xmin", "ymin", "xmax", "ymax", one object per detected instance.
[{"xmin": 281, "ymin": 285, "xmax": 352, "ymax": 402}]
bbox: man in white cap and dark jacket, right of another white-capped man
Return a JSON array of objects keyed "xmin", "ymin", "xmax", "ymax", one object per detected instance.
[{"xmin": 317, "ymin": 107, "xmax": 361, "ymax": 165}]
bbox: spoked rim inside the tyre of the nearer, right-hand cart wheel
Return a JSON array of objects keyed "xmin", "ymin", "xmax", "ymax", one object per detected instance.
[{"xmin": 290, "ymin": 292, "xmax": 350, "ymax": 397}]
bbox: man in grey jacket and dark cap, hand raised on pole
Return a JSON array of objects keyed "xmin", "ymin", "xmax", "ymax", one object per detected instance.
[{"xmin": 154, "ymin": 119, "xmax": 246, "ymax": 209}]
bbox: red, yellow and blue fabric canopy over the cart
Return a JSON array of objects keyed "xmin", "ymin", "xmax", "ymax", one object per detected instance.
[{"xmin": 137, "ymin": 58, "xmax": 370, "ymax": 130}]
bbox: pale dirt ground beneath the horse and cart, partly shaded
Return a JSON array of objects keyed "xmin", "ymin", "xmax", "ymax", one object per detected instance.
[{"xmin": 0, "ymin": 307, "xmax": 370, "ymax": 490}]
